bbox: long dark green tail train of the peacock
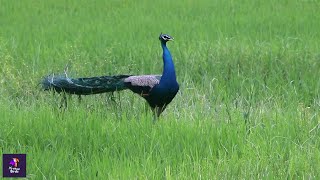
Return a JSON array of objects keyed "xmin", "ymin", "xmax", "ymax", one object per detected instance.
[{"xmin": 41, "ymin": 75, "xmax": 130, "ymax": 95}]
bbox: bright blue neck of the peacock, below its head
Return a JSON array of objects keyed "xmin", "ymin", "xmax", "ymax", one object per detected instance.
[{"xmin": 160, "ymin": 42, "xmax": 176, "ymax": 84}]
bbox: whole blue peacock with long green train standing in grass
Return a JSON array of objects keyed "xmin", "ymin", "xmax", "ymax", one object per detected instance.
[{"xmin": 42, "ymin": 33, "xmax": 179, "ymax": 118}]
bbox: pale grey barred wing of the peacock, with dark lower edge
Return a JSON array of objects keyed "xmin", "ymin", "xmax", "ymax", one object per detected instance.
[{"xmin": 124, "ymin": 75, "xmax": 161, "ymax": 97}]
